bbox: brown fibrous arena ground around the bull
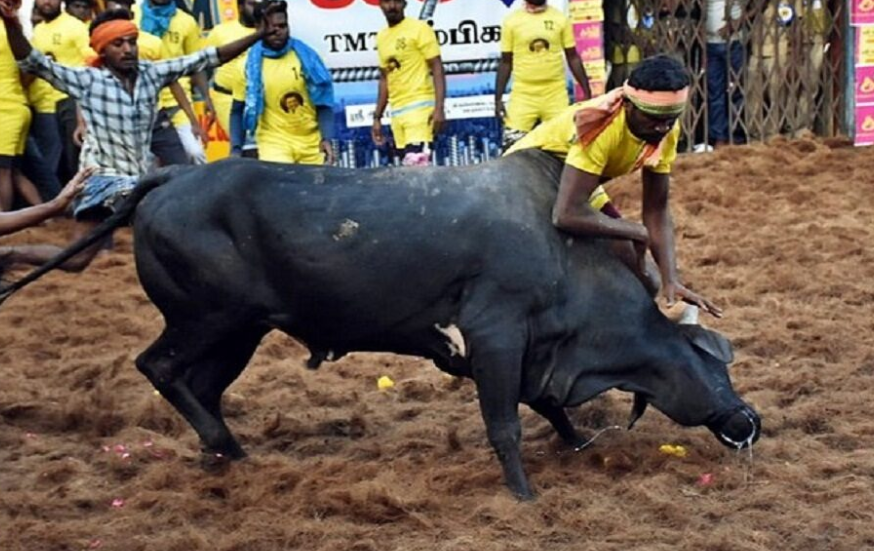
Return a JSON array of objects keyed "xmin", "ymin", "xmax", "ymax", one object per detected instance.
[{"xmin": 0, "ymin": 135, "xmax": 874, "ymax": 551}]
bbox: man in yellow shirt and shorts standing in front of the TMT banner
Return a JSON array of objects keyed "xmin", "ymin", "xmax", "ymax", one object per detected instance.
[{"xmin": 371, "ymin": 0, "xmax": 446, "ymax": 164}]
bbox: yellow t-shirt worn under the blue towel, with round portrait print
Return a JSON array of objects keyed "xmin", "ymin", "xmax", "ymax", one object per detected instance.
[{"xmin": 232, "ymin": 51, "xmax": 319, "ymax": 143}]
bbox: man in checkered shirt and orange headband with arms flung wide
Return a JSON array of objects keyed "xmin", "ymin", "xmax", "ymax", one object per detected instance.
[{"xmin": 0, "ymin": 0, "xmax": 274, "ymax": 271}]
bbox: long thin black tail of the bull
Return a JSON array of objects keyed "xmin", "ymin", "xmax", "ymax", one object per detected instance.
[{"xmin": 0, "ymin": 166, "xmax": 183, "ymax": 304}]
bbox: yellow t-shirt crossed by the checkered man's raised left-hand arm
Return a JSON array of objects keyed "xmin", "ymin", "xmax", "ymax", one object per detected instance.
[{"xmin": 27, "ymin": 11, "xmax": 95, "ymax": 113}]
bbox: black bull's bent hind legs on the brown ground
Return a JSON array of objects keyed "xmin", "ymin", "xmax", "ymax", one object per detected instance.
[{"xmin": 137, "ymin": 323, "xmax": 264, "ymax": 459}]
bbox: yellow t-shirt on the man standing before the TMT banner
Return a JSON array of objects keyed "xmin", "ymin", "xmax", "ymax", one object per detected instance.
[{"xmin": 376, "ymin": 17, "xmax": 440, "ymax": 112}]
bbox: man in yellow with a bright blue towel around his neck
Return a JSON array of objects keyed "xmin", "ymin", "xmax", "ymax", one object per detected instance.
[{"xmin": 230, "ymin": 0, "xmax": 334, "ymax": 165}]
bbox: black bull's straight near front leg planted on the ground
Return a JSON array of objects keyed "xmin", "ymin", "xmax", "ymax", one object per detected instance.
[{"xmin": 472, "ymin": 344, "xmax": 534, "ymax": 500}]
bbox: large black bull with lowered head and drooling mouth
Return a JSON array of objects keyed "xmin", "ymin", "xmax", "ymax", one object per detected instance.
[{"xmin": 3, "ymin": 151, "xmax": 760, "ymax": 497}]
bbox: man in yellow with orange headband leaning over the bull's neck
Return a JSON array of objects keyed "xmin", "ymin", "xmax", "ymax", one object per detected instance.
[{"xmin": 507, "ymin": 55, "xmax": 722, "ymax": 321}]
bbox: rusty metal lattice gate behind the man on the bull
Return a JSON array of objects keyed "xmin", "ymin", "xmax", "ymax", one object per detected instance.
[{"xmin": 603, "ymin": 0, "xmax": 847, "ymax": 150}]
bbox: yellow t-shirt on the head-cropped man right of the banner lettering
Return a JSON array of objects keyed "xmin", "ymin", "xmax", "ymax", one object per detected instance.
[{"xmin": 501, "ymin": 6, "xmax": 574, "ymax": 94}]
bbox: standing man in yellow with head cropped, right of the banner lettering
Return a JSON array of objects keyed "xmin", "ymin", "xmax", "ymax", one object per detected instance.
[{"xmin": 495, "ymin": 0, "xmax": 592, "ymax": 149}]
